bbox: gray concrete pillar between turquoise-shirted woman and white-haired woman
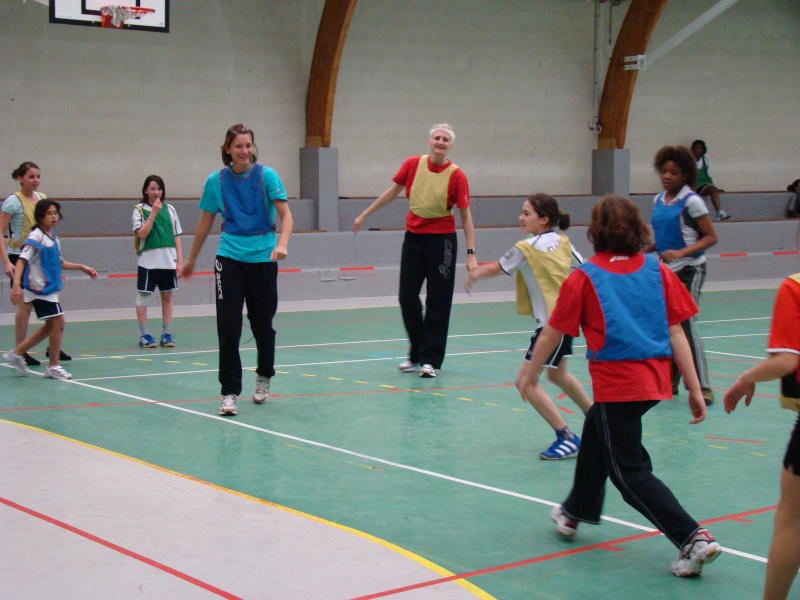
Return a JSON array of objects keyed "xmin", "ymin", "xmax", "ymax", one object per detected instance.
[{"xmin": 300, "ymin": 147, "xmax": 339, "ymax": 231}]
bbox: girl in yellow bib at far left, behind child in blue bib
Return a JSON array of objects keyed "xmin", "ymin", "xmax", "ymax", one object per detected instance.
[{"xmin": 0, "ymin": 161, "xmax": 72, "ymax": 367}]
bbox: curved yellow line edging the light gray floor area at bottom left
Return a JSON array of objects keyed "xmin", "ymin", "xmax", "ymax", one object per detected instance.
[{"xmin": 0, "ymin": 419, "xmax": 496, "ymax": 600}]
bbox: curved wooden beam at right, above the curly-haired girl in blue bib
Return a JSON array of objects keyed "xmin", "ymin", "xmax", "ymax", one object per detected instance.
[{"xmin": 597, "ymin": 0, "xmax": 669, "ymax": 150}]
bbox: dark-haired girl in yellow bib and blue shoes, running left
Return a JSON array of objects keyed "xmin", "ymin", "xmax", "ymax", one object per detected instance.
[{"xmin": 466, "ymin": 194, "xmax": 592, "ymax": 460}]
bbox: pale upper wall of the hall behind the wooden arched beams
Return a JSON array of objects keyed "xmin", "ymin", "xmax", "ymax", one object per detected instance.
[{"xmin": 0, "ymin": 0, "xmax": 800, "ymax": 198}]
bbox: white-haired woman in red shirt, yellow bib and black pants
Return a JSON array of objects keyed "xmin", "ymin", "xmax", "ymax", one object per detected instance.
[{"xmin": 353, "ymin": 123, "xmax": 478, "ymax": 377}]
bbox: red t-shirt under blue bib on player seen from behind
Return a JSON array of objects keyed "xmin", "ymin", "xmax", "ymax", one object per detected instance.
[{"xmin": 548, "ymin": 252, "xmax": 698, "ymax": 402}]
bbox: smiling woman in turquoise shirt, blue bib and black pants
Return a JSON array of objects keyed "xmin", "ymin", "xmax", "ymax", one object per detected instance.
[{"xmin": 183, "ymin": 124, "xmax": 293, "ymax": 416}]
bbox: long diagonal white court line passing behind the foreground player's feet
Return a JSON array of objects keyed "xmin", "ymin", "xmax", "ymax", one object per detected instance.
[{"xmin": 40, "ymin": 379, "xmax": 767, "ymax": 563}]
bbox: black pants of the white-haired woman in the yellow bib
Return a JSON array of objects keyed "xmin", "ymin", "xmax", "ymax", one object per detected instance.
[{"xmin": 399, "ymin": 231, "xmax": 458, "ymax": 369}]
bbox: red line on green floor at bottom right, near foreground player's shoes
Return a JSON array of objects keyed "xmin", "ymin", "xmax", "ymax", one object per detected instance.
[{"xmin": 352, "ymin": 506, "xmax": 777, "ymax": 600}]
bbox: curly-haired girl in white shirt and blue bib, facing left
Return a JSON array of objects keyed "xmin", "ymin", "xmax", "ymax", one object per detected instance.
[{"xmin": 645, "ymin": 146, "xmax": 717, "ymax": 404}]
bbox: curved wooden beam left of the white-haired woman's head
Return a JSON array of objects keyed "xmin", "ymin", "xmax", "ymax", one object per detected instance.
[{"xmin": 306, "ymin": 0, "xmax": 357, "ymax": 148}]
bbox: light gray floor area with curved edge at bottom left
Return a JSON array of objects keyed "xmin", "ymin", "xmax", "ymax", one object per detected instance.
[{"xmin": 0, "ymin": 421, "xmax": 488, "ymax": 600}]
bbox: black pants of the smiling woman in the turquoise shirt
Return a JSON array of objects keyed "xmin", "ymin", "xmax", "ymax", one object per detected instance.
[{"xmin": 214, "ymin": 256, "xmax": 278, "ymax": 396}]
